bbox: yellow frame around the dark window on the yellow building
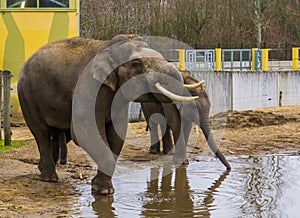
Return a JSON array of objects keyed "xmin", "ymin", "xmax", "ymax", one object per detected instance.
[{"xmin": 0, "ymin": 0, "xmax": 78, "ymax": 12}]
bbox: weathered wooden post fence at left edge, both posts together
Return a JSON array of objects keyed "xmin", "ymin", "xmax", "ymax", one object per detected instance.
[{"xmin": 0, "ymin": 70, "xmax": 12, "ymax": 146}]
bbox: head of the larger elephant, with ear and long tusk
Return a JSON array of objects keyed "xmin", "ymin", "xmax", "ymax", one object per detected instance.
[{"xmin": 91, "ymin": 35, "xmax": 196, "ymax": 102}]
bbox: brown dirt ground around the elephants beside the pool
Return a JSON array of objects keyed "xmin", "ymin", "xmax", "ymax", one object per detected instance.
[{"xmin": 0, "ymin": 106, "xmax": 300, "ymax": 217}]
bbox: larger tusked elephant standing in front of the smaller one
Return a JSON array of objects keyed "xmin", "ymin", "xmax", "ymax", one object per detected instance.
[{"xmin": 18, "ymin": 35, "xmax": 198, "ymax": 195}]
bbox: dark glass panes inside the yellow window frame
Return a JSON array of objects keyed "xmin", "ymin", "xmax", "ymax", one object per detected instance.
[{"xmin": 6, "ymin": 0, "xmax": 69, "ymax": 8}]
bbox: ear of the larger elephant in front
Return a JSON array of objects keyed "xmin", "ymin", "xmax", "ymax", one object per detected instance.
[{"xmin": 91, "ymin": 49, "xmax": 118, "ymax": 91}]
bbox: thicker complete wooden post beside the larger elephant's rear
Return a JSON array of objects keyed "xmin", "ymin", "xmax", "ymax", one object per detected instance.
[{"xmin": 2, "ymin": 70, "xmax": 11, "ymax": 146}]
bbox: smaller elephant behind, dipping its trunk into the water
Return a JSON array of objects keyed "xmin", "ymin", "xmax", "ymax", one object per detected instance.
[{"xmin": 141, "ymin": 71, "xmax": 231, "ymax": 170}]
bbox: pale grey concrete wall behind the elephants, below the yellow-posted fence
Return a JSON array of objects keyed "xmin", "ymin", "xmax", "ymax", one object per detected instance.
[{"xmin": 129, "ymin": 71, "xmax": 300, "ymax": 120}]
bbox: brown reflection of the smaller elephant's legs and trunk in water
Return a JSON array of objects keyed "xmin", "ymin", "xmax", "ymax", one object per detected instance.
[{"xmin": 142, "ymin": 166, "xmax": 230, "ymax": 217}]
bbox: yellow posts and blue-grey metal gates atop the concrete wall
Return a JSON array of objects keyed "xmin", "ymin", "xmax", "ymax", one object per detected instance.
[{"xmin": 177, "ymin": 47, "xmax": 300, "ymax": 72}]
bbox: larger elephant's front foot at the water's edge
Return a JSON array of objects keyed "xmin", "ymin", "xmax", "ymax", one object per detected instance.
[{"xmin": 92, "ymin": 171, "xmax": 115, "ymax": 196}]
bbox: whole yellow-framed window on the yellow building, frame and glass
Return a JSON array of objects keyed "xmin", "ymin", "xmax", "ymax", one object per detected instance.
[{"xmin": 0, "ymin": 0, "xmax": 77, "ymax": 10}]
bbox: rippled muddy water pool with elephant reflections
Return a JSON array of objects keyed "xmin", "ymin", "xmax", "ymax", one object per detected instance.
[{"xmin": 75, "ymin": 156, "xmax": 300, "ymax": 217}]
